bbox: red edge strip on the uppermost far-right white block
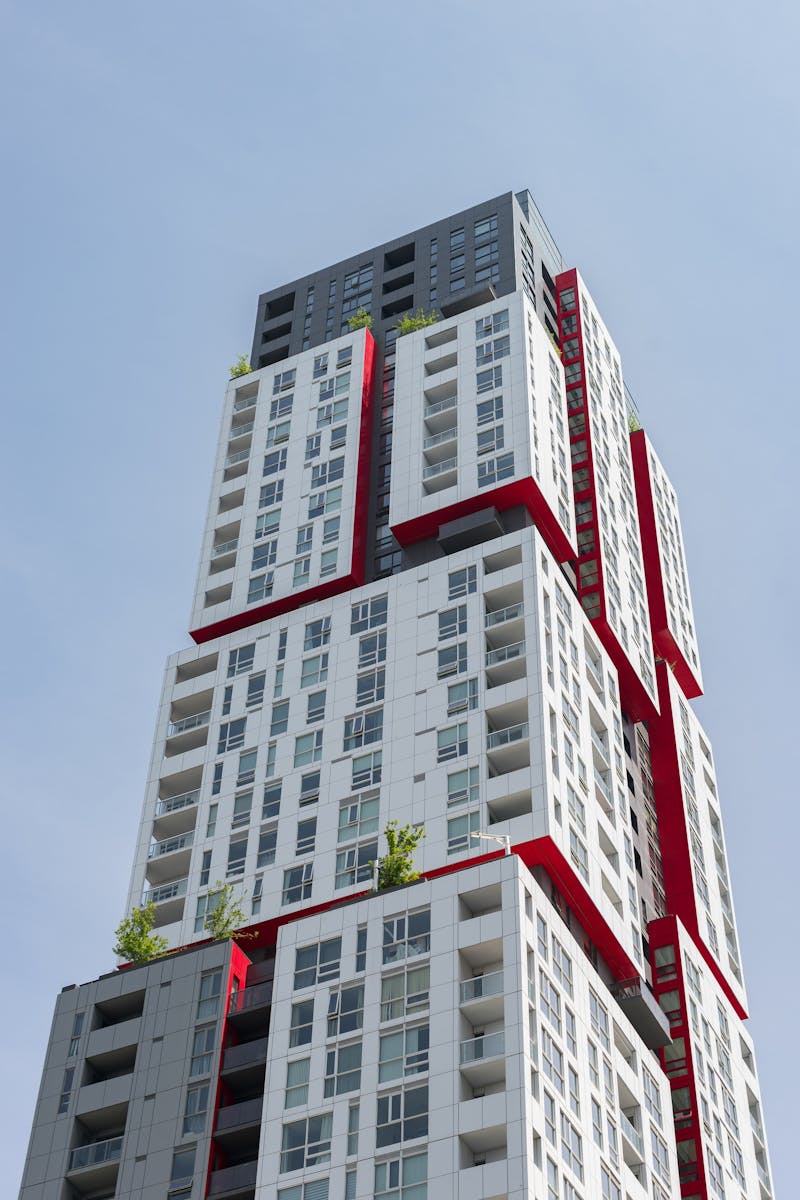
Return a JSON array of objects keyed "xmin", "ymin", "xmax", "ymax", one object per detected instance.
[{"xmin": 631, "ymin": 430, "xmax": 703, "ymax": 700}]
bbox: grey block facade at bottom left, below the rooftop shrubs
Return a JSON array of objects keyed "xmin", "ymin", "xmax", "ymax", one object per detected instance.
[{"xmin": 20, "ymin": 942, "xmax": 237, "ymax": 1200}]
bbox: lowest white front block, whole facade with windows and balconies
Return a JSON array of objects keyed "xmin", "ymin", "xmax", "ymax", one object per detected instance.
[{"xmin": 257, "ymin": 856, "xmax": 680, "ymax": 1200}]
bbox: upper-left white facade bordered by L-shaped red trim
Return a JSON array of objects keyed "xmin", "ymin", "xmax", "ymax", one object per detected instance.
[{"xmin": 190, "ymin": 330, "xmax": 369, "ymax": 630}]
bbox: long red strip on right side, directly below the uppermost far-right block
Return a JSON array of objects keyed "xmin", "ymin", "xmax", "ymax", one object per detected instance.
[{"xmin": 648, "ymin": 662, "xmax": 747, "ymax": 1021}]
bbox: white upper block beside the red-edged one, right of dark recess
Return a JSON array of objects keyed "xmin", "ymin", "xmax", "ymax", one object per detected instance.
[{"xmin": 390, "ymin": 292, "xmax": 575, "ymax": 545}]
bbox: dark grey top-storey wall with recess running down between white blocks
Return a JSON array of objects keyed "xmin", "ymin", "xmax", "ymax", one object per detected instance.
[{"xmin": 251, "ymin": 191, "xmax": 564, "ymax": 581}]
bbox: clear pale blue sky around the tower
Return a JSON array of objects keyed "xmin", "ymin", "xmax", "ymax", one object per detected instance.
[{"xmin": 0, "ymin": 0, "xmax": 800, "ymax": 1196}]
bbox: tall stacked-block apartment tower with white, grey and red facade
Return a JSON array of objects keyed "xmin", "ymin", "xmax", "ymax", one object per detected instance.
[{"xmin": 22, "ymin": 192, "xmax": 772, "ymax": 1200}]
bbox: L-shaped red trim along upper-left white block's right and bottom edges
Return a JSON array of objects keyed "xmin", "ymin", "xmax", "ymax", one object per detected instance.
[{"xmin": 191, "ymin": 330, "xmax": 375, "ymax": 646}]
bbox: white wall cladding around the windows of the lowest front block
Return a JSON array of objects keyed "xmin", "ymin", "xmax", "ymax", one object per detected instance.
[{"xmin": 257, "ymin": 856, "xmax": 680, "ymax": 1200}]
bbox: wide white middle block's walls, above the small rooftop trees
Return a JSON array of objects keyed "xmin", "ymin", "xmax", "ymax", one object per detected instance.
[{"xmin": 130, "ymin": 529, "xmax": 642, "ymax": 967}]
